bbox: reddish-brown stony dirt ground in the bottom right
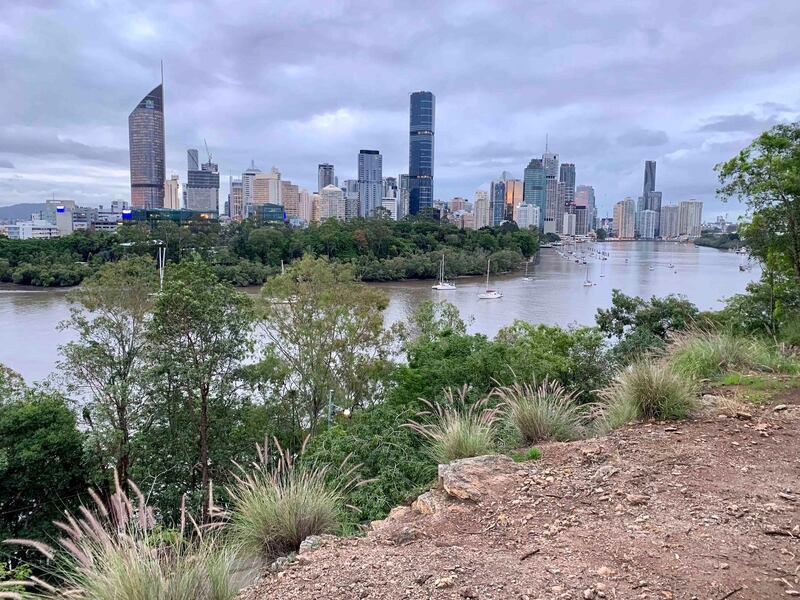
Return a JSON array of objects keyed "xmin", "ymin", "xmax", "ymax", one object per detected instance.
[{"xmin": 241, "ymin": 390, "xmax": 800, "ymax": 600}]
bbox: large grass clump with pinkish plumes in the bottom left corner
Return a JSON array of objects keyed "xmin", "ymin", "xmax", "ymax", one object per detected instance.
[{"xmin": 0, "ymin": 474, "xmax": 237, "ymax": 600}]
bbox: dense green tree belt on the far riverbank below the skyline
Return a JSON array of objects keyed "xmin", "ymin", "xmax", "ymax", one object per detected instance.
[{"xmin": 0, "ymin": 217, "xmax": 538, "ymax": 287}]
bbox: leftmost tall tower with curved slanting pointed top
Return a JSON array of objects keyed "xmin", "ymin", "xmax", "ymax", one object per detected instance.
[{"xmin": 128, "ymin": 84, "xmax": 167, "ymax": 208}]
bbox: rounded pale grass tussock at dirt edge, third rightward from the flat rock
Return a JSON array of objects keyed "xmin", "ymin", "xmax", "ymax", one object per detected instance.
[{"xmin": 599, "ymin": 361, "xmax": 697, "ymax": 430}]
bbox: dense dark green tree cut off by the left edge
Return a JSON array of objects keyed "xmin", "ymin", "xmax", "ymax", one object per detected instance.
[{"xmin": 0, "ymin": 387, "xmax": 86, "ymax": 550}]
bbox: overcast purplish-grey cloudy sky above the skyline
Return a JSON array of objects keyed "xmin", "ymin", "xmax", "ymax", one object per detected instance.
[{"xmin": 0, "ymin": 0, "xmax": 800, "ymax": 219}]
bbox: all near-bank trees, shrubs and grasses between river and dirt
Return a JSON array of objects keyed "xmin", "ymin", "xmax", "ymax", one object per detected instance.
[{"xmin": 0, "ymin": 122, "xmax": 800, "ymax": 600}]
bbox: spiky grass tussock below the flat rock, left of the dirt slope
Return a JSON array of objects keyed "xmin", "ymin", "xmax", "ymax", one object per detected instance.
[{"xmin": 227, "ymin": 441, "xmax": 358, "ymax": 559}]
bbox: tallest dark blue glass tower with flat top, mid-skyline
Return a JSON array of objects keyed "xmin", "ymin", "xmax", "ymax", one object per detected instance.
[{"xmin": 408, "ymin": 92, "xmax": 436, "ymax": 215}]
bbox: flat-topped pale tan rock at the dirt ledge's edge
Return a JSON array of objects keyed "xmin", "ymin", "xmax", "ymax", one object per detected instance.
[{"xmin": 439, "ymin": 454, "xmax": 517, "ymax": 502}]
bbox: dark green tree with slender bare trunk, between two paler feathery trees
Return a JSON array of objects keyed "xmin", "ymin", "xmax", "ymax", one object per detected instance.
[{"xmin": 148, "ymin": 256, "xmax": 254, "ymax": 521}]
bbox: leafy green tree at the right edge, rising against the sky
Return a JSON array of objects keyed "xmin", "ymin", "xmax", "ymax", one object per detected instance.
[{"xmin": 715, "ymin": 123, "xmax": 800, "ymax": 280}]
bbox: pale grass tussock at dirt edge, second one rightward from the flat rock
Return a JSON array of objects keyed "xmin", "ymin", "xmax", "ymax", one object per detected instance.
[{"xmin": 492, "ymin": 381, "xmax": 585, "ymax": 444}]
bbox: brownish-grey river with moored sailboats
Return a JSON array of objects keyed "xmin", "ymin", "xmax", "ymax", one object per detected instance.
[{"xmin": 0, "ymin": 242, "xmax": 760, "ymax": 382}]
